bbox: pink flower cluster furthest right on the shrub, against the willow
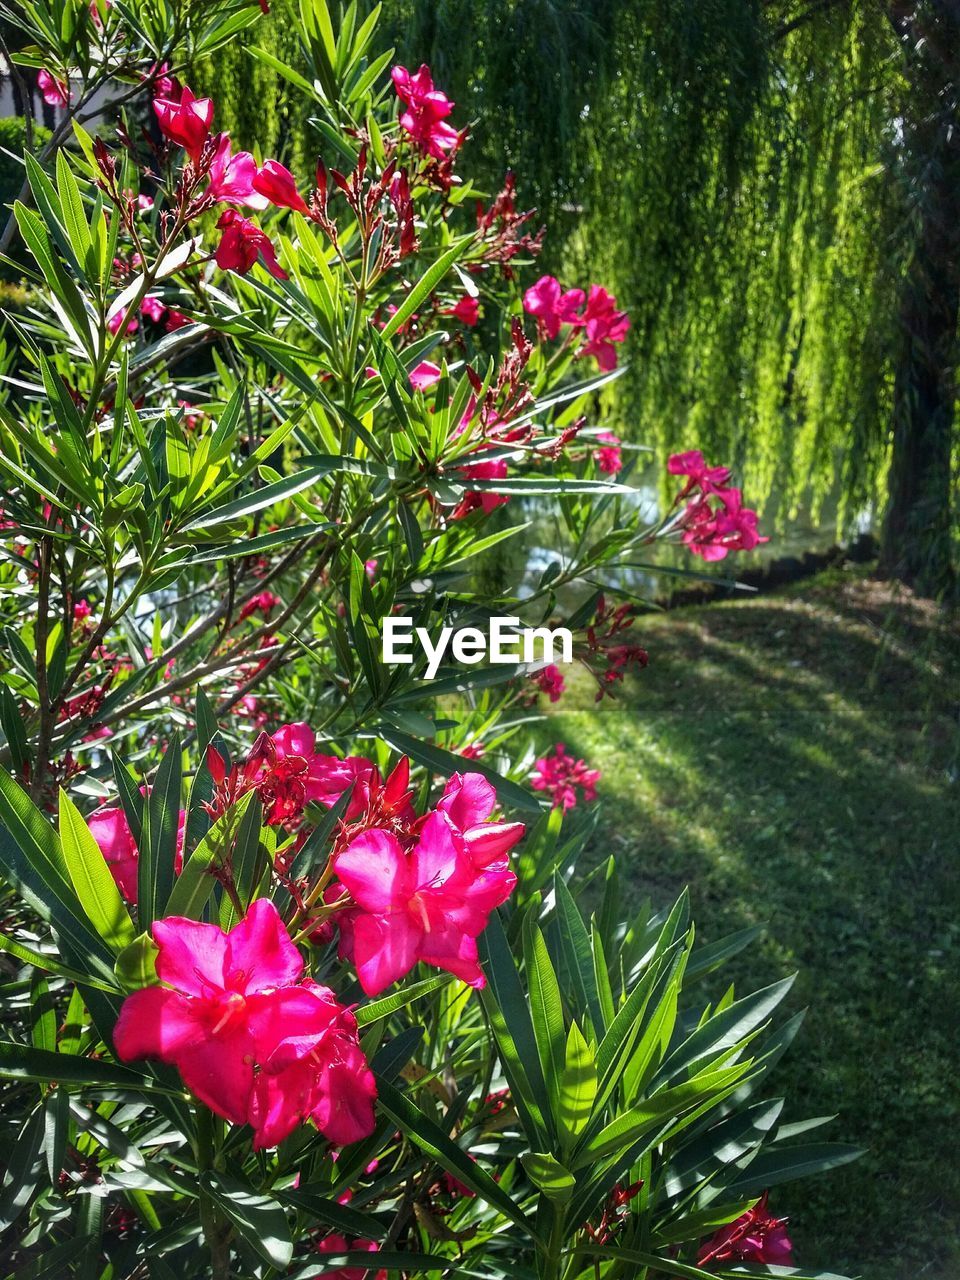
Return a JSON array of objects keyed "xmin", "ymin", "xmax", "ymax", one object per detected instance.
[{"xmin": 667, "ymin": 449, "xmax": 769, "ymax": 562}]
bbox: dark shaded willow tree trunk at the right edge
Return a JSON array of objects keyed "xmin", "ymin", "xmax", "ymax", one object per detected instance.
[{"xmin": 881, "ymin": 3, "xmax": 960, "ymax": 598}]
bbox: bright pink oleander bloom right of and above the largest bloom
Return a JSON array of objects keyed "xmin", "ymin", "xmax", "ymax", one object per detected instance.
[{"xmin": 333, "ymin": 813, "xmax": 517, "ymax": 996}]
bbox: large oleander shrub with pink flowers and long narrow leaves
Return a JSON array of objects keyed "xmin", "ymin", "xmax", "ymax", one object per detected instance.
[{"xmin": 0, "ymin": 0, "xmax": 855, "ymax": 1280}]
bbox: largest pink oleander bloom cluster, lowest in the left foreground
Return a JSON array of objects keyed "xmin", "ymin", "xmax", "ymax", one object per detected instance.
[{"xmin": 114, "ymin": 899, "xmax": 375, "ymax": 1148}]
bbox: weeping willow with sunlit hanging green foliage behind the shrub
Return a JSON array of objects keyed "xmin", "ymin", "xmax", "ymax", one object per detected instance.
[{"xmin": 193, "ymin": 0, "xmax": 960, "ymax": 594}]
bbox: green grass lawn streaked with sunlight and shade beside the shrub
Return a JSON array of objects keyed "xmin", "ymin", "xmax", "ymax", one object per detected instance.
[{"xmin": 552, "ymin": 570, "xmax": 960, "ymax": 1280}]
